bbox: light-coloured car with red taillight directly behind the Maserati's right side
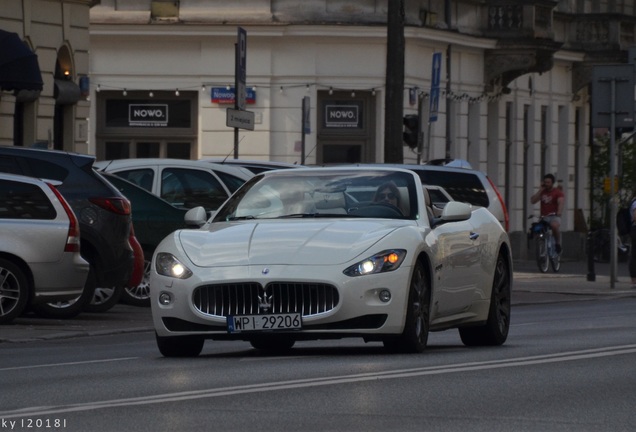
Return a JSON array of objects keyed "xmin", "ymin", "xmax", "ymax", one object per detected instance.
[{"xmin": 357, "ymin": 159, "xmax": 510, "ymax": 232}]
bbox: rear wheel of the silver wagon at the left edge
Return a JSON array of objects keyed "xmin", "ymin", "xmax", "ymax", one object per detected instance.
[{"xmin": 0, "ymin": 258, "xmax": 29, "ymax": 324}]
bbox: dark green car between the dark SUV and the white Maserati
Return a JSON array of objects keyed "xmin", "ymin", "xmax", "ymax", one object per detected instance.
[{"xmin": 102, "ymin": 172, "xmax": 187, "ymax": 306}]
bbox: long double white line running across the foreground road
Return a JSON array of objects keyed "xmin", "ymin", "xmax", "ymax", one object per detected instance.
[{"xmin": 0, "ymin": 344, "xmax": 636, "ymax": 419}]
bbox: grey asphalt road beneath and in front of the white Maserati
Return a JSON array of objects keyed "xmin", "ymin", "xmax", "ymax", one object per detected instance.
[{"xmin": 0, "ymin": 297, "xmax": 636, "ymax": 432}]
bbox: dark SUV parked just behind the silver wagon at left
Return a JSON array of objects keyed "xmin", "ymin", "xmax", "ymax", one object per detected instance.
[{"xmin": 0, "ymin": 146, "xmax": 134, "ymax": 318}]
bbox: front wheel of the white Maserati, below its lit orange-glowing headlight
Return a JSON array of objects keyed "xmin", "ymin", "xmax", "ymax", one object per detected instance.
[{"xmin": 384, "ymin": 261, "xmax": 431, "ymax": 353}]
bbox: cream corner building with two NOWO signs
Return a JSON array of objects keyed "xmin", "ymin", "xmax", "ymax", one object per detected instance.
[{"xmin": 0, "ymin": 0, "xmax": 636, "ymax": 257}]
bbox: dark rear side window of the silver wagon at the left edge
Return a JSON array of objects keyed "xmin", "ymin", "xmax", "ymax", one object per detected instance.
[{"xmin": 0, "ymin": 180, "xmax": 57, "ymax": 219}]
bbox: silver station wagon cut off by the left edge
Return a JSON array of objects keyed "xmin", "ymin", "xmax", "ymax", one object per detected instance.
[{"xmin": 0, "ymin": 173, "xmax": 89, "ymax": 324}]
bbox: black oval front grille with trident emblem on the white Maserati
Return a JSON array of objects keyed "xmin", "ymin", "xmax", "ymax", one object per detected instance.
[{"xmin": 192, "ymin": 282, "xmax": 339, "ymax": 317}]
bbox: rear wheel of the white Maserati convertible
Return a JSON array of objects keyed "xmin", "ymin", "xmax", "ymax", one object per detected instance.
[{"xmin": 459, "ymin": 254, "xmax": 512, "ymax": 346}]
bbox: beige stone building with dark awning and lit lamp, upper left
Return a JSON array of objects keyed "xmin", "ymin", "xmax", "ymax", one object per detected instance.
[{"xmin": 0, "ymin": 0, "xmax": 95, "ymax": 153}]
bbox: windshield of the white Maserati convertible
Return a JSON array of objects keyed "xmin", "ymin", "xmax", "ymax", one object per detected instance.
[{"xmin": 214, "ymin": 168, "xmax": 418, "ymax": 222}]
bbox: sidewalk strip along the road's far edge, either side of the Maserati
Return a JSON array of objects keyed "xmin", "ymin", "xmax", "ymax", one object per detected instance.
[{"xmin": 0, "ymin": 261, "xmax": 636, "ymax": 347}]
